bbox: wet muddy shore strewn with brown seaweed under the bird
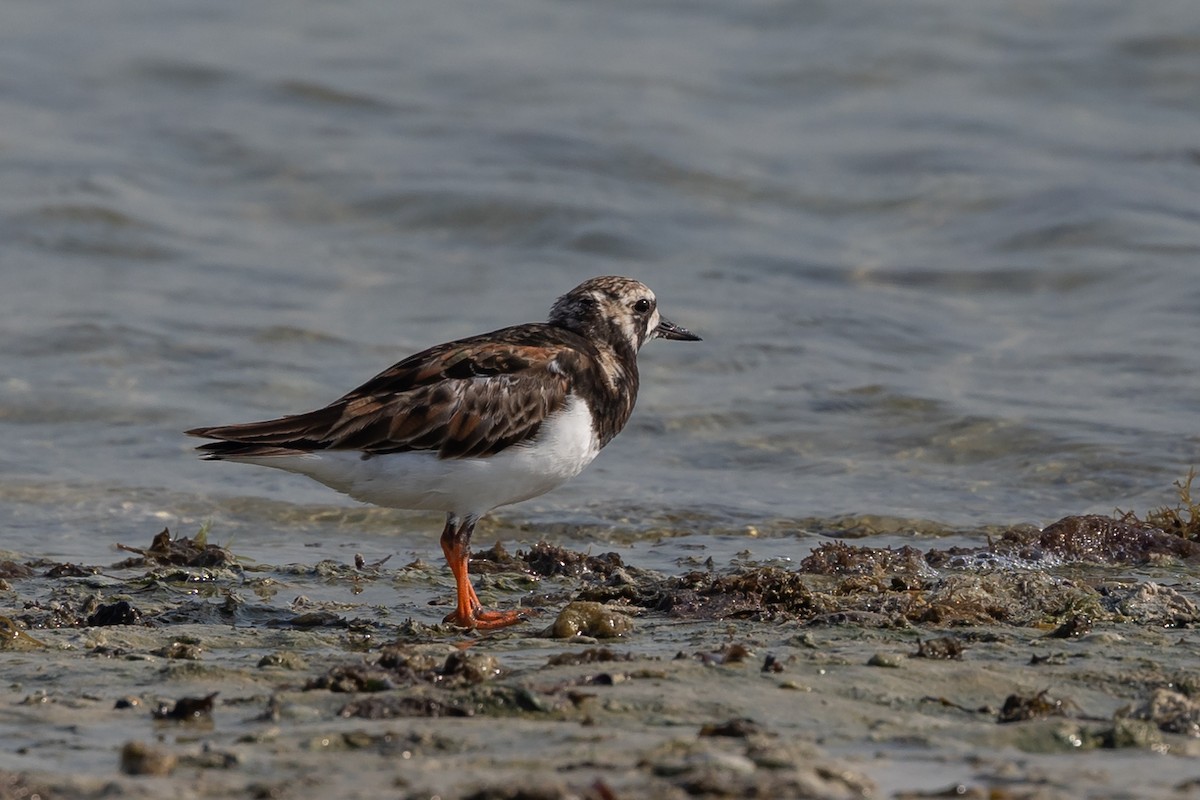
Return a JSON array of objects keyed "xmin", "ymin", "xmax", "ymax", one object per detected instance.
[{"xmin": 0, "ymin": 517, "xmax": 1200, "ymax": 800}]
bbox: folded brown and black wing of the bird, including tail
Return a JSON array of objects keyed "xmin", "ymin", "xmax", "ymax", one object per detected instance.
[{"xmin": 187, "ymin": 325, "xmax": 581, "ymax": 458}]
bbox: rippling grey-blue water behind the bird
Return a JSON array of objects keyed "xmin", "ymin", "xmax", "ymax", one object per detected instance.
[{"xmin": 0, "ymin": 0, "xmax": 1200, "ymax": 563}]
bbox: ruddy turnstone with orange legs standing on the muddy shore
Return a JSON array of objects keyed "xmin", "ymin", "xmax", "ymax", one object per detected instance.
[{"xmin": 187, "ymin": 276, "xmax": 700, "ymax": 628}]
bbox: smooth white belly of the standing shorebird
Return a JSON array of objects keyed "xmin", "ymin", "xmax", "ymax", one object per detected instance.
[{"xmin": 243, "ymin": 398, "xmax": 600, "ymax": 515}]
